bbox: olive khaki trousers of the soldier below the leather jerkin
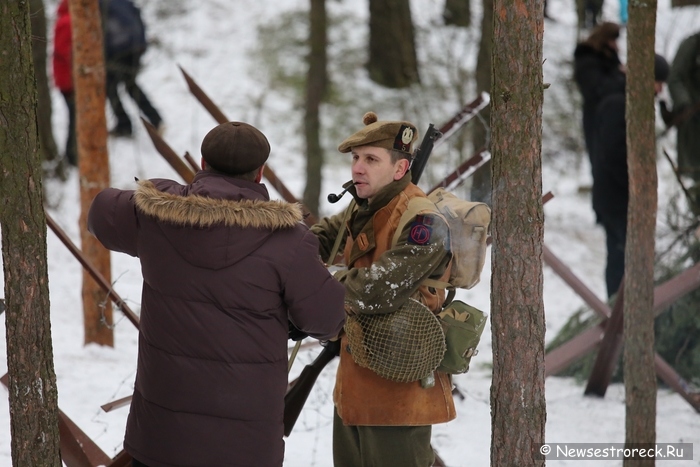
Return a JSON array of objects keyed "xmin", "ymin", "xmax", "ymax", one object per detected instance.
[{"xmin": 333, "ymin": 409, "xmax": 435, "ymax": 467}]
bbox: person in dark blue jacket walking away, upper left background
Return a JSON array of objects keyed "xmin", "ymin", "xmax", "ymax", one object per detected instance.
[{"xmin": 100, "ymin": 0, "xmax": 163, "ymax": 136}]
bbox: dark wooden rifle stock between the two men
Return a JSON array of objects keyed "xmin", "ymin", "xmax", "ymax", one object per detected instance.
[{"xmin": 284, "ymin": 339, "xmax": 340, "ymax": 436}]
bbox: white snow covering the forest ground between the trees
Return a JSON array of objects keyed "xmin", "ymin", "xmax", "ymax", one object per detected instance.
[{"xmin": 0, "ymin": 0, "xmax": 700, "ymax": 467}]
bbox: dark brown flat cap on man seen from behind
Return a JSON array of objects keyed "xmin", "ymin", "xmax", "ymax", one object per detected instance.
[{"xmin": 201, "ymin": 122, "xmax": 270, "ymax": 175}]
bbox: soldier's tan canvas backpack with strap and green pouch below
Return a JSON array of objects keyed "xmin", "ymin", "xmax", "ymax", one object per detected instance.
[{"xmin": 392, "ymin": 188, "xmax": 491, "ymax": 374}]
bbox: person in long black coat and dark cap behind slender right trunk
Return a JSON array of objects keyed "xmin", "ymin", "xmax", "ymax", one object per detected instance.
[{"xmin": 592, "ymin": 54, "xmax": 669, "ymax": 297}]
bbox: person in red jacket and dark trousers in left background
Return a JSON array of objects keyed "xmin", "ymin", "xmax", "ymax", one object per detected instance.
[{"xmin": 52, "ymin": 0, "xmax": 78, "ymax": 166}]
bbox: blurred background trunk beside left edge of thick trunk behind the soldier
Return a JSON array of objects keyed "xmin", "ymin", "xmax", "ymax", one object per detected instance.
[{"xmin": 471, "ymin": 0, "xmax": 493, "ymax": 205}]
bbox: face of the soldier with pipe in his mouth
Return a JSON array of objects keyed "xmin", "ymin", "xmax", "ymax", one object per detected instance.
[{"xmin": 352, "ymin": 146, "xmax": 408, "ymax": 199}]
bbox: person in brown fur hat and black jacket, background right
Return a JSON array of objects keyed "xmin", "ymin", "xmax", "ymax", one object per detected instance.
[{"xmin": 574, "ymin": 22, "xmax": 625, "ymax": 172}]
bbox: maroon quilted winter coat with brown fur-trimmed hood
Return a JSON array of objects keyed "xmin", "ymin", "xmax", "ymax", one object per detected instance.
[{"xmin": 88, "ymin": 172, "xmax": 345, "ymax": 467}]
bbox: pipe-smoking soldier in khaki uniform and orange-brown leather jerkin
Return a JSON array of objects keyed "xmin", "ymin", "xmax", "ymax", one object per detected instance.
[{"xmin": 311, "ymin": 112, "xmax": 455, "ymax": 467}]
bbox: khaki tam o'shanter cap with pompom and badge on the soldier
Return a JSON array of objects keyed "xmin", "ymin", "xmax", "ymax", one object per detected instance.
[{"xmin": 338, "ymin": 112, "xmax": 418, "ymax": 154}]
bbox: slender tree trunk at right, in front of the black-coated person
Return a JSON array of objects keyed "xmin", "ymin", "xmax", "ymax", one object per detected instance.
[{"xmin": 623, "ymin": 0, "xmax": 657, "ymax": 466}]
